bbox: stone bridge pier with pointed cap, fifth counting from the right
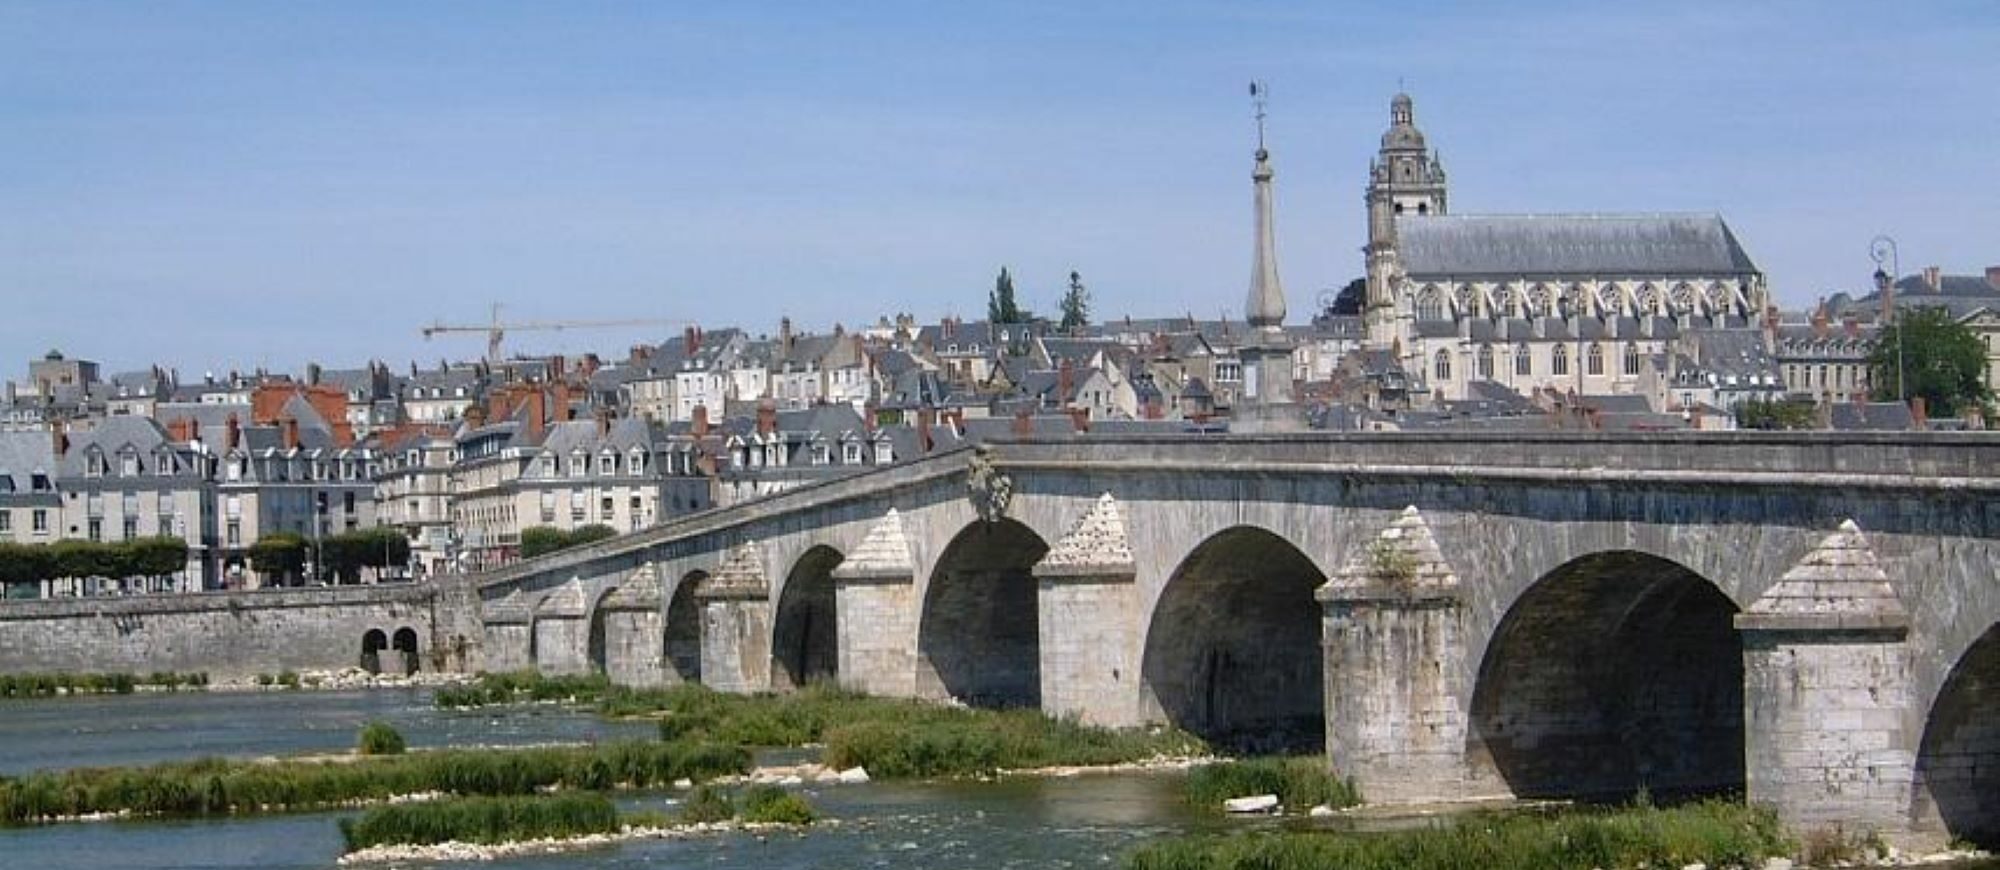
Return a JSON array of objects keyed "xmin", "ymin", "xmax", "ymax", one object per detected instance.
[{"xmin": 694, "ymin": 544, "xmax": 770, "ymax": 694}]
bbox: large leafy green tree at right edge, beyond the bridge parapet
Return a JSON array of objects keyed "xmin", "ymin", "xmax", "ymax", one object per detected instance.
[{"xmin": 1868, "ymin": 308, "xmax": 1994, "ymax": 416}]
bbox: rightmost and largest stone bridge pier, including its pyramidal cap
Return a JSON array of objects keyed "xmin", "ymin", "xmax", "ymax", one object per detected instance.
[{"xmin": 1736, "ymin": 520, "xmax": 1916, "ymax": 834}]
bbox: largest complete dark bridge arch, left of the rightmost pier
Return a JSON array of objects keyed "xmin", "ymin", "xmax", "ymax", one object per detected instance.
[{"xmin": 1470, "ymin": 550, "xmax": 1744, "ymax": 800}]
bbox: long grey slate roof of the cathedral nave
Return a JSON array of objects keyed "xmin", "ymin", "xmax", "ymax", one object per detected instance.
[{"xmin": 1396, "ymin": 214, "xmax": 1758, "ymax": 278}]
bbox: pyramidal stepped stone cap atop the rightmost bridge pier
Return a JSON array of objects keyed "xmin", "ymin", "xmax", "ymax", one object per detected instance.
[{"xmin": 1736, "ymin": 520, "xmax": 1910, "ymax": 630}]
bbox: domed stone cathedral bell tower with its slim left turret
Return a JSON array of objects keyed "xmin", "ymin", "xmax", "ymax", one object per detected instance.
[{"xmin": 1362, "ymin": 94, "xmax": 1446, "ymax": 348}]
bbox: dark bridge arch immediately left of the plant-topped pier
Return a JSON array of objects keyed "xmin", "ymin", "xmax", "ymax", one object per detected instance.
[{"xmin": 1140, "ymin": 526, "xmax": 1326, "ymax": 752}]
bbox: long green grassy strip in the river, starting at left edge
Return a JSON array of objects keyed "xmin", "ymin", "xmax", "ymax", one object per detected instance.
[{"xmin": 0, "ymin": 740, "xmax": 750, "ymax": 824}]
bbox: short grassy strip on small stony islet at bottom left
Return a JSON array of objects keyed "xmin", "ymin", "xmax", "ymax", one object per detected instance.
[{"xmin": 340, "ymin": 794, "xmax": 620, "ymax": 852}]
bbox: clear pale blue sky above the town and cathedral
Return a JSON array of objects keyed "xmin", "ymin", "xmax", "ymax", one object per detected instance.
[{"xmin": 0, "ymin": 0, "xmax": 2000, "ymax": 380}]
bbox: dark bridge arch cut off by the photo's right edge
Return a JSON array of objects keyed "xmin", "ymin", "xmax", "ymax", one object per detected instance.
[{"xmin": 1916, "ymin": 624, "xmax": 2000, "ymax": 850}]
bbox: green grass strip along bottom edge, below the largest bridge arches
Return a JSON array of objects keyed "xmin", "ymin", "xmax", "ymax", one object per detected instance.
[{"xmin": 1126, "ymin": 800, "xmax": 1792, "ymax": 870}]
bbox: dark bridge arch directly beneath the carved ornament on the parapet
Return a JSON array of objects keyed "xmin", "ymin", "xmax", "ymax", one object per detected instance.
[{"xmin": 916, "ymin": 520, "xmax": 1048, "ymax": 708}]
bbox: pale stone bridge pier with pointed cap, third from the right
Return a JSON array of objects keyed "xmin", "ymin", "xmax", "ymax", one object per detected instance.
[{"xmin": 1034, "ymin": 492, "xmax": 1142, "ymax": 728}]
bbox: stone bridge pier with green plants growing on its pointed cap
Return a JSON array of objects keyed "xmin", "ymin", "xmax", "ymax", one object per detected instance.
[{"xmin": 1316, "ymin": 506, "xmax": 1472, "ymax": 804}]
